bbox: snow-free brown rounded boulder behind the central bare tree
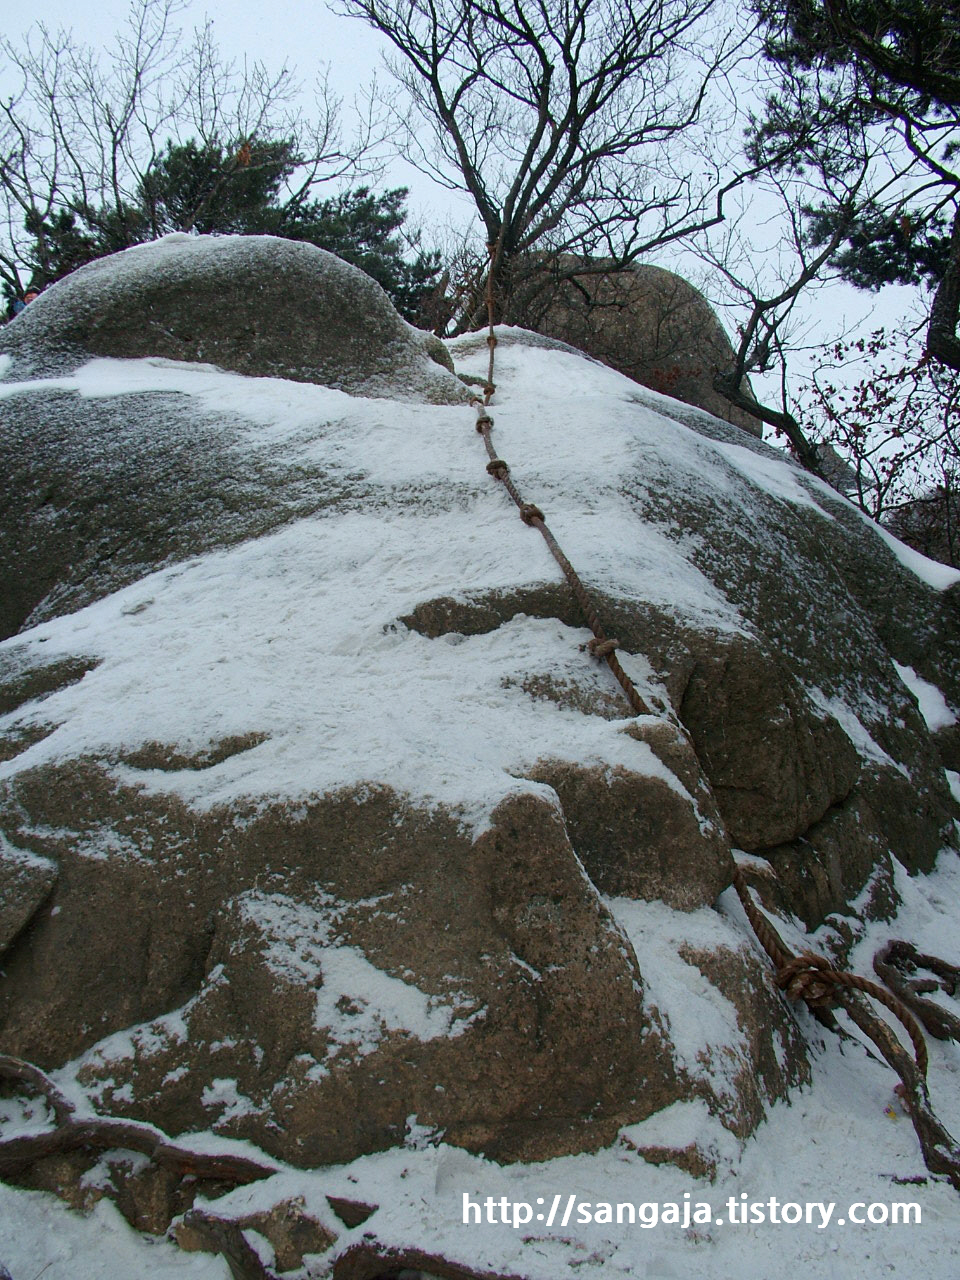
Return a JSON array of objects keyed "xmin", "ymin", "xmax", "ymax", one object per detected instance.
[{"xmin": 518, "ymin": 264, "xmax": 763, "ymax": 436}]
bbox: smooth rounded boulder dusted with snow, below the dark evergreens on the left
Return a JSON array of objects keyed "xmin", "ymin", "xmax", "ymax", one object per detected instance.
[{"xmin": 0, "ymin": 233, "xmax": 467, "ymax": 403}]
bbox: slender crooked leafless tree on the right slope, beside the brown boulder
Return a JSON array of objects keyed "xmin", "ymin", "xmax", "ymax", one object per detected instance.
[{"xmin": 698, "ymin": 27, "xmax": 957, "ymax": 468}]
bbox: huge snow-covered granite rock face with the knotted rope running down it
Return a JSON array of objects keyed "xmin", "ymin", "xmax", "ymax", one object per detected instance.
[{"xmin": 0, "ymin": 262, "xmax": 960, "ymax": 1169}]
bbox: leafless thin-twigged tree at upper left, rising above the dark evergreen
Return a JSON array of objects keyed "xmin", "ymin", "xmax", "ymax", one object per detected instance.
[{"xmin": 0, "ymin": 0, "xmax": 370, "ymax": 299}]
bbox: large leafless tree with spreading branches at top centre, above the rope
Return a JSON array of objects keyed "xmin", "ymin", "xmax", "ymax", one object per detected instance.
[{"xmin": 339, "ymin": 0, "xmax": 762, "ymax": 325}]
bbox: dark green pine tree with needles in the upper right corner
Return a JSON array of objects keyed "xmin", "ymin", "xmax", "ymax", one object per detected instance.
[{"xmin": 751, "ymin": 0, "xmax": 960, "ymax": 404}]
